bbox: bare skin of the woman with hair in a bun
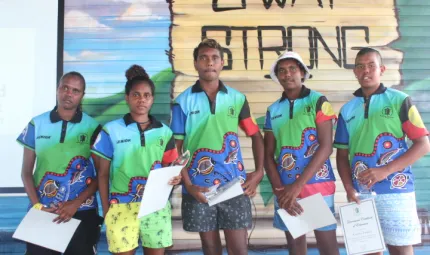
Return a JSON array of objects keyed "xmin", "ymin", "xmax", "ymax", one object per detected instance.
[{"xmin": 95, "ymin": 82, "xmax": 181, "ymax": 255}]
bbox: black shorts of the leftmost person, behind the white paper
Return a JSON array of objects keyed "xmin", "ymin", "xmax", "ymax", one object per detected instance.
[{"xmin": 25, "ymin": 209, "xmax": 103, "ymax": 255}]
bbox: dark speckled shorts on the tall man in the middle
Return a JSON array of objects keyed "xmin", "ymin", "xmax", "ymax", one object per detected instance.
[{"xmin": 182, "ymin": 194, "xmax": 252, "ymax": 232}]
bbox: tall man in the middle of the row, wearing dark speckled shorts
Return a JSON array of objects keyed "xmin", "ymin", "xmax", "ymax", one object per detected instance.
[{"xmin": 171, "ymin": 39, "xmax": 263, "ymax": 255}]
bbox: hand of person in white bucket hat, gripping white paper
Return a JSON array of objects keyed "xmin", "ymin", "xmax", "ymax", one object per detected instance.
[{"xmin": 278, "ymin": 183, "xmax": 303, "ymax": 216}]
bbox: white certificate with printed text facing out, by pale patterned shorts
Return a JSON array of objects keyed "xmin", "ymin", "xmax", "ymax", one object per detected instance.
[{"xmin": 339, "ymin": 198, "xmax": 385, "ymax": 255}]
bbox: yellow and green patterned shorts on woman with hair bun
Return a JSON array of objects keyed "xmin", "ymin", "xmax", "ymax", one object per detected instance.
[{"xmin": 105, "ymin": 203, "xmax": 173, "ymax": 253}]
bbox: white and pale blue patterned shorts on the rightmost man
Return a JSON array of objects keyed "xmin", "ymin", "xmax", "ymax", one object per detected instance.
[{"xmin": 375, "ymin": 192, "xmax": 421, "ymax": 246}]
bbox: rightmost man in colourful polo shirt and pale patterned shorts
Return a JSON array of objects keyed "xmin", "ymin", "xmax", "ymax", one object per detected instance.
[{"xmin": 334, "ymin": 48, "xmax": 430, "ymax": 255}]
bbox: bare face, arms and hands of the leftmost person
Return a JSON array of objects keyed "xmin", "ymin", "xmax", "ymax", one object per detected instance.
[{"xmin": 21, "ymin": 76, "xmax": 98, "ymax": 223}]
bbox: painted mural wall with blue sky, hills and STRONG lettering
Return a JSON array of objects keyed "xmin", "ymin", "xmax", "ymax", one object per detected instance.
[{"xmin": 64, "ymin": 0, "xmax": 430, "ymax": 243}]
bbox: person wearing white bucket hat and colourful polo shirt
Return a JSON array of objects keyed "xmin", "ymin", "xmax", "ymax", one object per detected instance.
[{"xmin": 264, "ymin": 52, "xmax": 339, "ymax": 255}]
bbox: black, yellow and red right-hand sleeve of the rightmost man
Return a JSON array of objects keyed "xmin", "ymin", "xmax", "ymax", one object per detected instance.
[{"xmin": 399, "ymin": 97, "xmax": 429, "ymax": 140}]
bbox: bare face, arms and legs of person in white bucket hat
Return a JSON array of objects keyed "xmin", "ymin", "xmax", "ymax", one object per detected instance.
[{"xmin": 264, "ymin": 59, "xmax": 339, "ymax": 255}]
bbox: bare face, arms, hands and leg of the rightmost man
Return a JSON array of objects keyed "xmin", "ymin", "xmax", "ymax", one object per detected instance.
[{"xmin": 336, "ymin": 53, "xmax": 430, "ymax": 255}]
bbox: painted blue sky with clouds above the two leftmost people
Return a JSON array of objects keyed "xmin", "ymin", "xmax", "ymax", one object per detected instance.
[{"xmin": 64, "ymin": 0, "xmax": 170, "ymax": 97}]
